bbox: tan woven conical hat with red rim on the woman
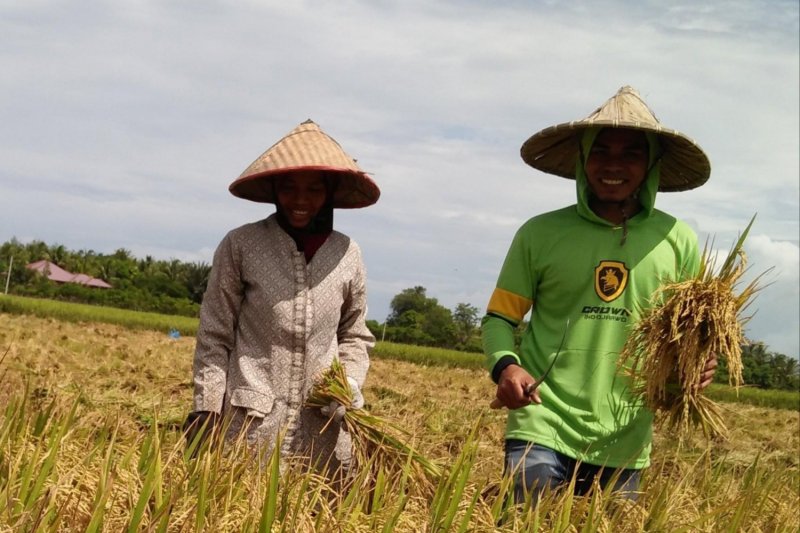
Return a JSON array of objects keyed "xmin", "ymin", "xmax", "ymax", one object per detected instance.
[{"xmin": 228, "ymin": 120, "xmax": 381, "ymax": 209}]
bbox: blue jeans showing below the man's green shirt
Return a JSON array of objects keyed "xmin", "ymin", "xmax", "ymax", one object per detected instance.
[{"xmin": 505, "ymin": 439, "xmax": 641, "ymax": 504}]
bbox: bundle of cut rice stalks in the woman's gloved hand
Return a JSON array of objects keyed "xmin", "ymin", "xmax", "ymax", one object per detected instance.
[{"xmin": 306, "ymin": 359, "xmax": 442, "ymax": 490}]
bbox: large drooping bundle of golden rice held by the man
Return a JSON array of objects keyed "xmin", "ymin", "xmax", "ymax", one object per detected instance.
[{"xmin": 620, "ymin": 217, "xmax": 763, "ymax": 437}]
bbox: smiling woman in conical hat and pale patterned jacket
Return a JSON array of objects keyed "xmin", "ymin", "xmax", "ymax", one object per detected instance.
[{"xmin": 187, "ymin": 120, "xmax": 380, "ymax": 469}]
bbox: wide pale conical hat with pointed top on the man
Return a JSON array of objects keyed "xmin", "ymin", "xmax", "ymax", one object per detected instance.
[{"xmin": 520, "ymin": 86, "xmax": 711, "ymax": 191}]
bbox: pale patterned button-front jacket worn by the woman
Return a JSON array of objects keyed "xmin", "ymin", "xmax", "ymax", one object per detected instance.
[{"xmin": 194, "ymin": 215, "xmax": 375, "ymax": 460}]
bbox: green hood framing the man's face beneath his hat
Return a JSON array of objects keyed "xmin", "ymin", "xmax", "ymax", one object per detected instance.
[{"xmin": 575, "ymin": 127, "xmax": 661, "ymax": 226}]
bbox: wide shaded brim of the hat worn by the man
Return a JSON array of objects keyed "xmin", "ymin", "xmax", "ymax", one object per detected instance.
[{"xmin": 520, "ymin": 120, "xmax": 711, "ymax": 192}]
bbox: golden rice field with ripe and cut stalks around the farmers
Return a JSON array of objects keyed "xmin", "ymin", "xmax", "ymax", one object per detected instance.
[{"xmin": 0, "ymin": 312, "xmax": 800, "ymax": 533}]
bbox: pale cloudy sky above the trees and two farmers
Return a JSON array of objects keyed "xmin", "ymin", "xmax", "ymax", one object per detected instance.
[{"xmin": 0, "ymin": 0, "xmax": 800, "ymax": 357}]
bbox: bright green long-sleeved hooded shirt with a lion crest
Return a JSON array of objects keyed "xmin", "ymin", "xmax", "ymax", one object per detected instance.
[{"xmin": 482, "ymin": 130, "xmax": 700, "ymax": 468}]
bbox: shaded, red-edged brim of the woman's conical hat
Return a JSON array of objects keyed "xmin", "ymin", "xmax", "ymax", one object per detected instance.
[{"xmin": 228, "ymin": 165, "xmax": 381, "ymax": 209}]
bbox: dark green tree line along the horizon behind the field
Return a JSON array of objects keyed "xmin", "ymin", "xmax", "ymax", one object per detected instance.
[{"xmin": 0, "ymin": 239, "xmax": 800, "ymax": 390}]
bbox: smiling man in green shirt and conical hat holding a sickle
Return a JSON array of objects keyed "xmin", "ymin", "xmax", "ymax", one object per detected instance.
[{"xmin": 482, "ymin": 87, "xmax": 716, "ymax": 502}]
